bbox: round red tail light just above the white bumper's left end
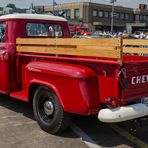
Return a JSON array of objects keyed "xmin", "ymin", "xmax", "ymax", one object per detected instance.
[{"xmin": 106, "ymin": 97, "xmax": 119, "ymax": 108}]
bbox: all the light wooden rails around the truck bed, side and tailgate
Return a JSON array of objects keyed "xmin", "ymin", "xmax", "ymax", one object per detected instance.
[{"xmin": 16, "ymin": 38, "xmax": 148, "ymax": 62}]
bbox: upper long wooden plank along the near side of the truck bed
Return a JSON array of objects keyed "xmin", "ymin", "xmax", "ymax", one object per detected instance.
[{"xmin": 16, "ymin": 38, "xmax": 120, "ymax": 47}]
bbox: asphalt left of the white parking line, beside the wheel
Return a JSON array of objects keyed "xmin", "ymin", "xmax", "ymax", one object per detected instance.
[{"xmin": 0, "ymin": 95, "xmax": 87, "ymax": 148}]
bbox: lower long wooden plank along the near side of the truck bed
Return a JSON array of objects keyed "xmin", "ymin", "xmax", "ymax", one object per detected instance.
[{"xmin": 17, "ymin": 46, "xmax": 120, "ymax": 59}]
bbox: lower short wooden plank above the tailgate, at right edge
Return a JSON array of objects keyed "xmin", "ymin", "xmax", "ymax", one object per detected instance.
[{"xmin": 123, "ymin": 47, "xmax": 148, "ymax": 54}]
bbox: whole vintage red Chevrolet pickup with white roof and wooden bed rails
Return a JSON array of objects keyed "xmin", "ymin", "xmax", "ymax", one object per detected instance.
[{"xmin": 0, "ymin": 14, "xmax": 148, "ymax": 134}]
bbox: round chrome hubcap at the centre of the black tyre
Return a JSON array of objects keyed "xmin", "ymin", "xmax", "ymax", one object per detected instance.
[{"xmin": 44, "ymin": 100, "xmax": 54, "ymax": 116}]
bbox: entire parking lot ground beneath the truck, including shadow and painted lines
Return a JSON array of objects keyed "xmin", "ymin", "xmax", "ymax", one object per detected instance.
[{"xmin": 0, "ymin": 95, "xmax": 148, "ymax": 148}]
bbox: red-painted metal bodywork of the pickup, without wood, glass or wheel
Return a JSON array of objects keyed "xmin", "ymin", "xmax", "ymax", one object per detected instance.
[{"xmin": 0, "ymin": 15, "xmax": 148, "ymax": 115}]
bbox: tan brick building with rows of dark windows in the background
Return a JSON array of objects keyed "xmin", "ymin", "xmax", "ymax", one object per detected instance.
[{"xmin": 34, "ymin": 2, "xmax": 148, "ymax": 32}]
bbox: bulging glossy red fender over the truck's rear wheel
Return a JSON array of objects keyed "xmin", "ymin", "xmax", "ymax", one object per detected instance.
[{"xmin": 25, "ymin": 61, "xmax": 99, "ymax": 114}]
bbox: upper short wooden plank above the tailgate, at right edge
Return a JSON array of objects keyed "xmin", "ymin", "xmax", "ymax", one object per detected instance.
[{"xmin": 123, "ymin": 39, "xmax": 148, "ymax": 46}]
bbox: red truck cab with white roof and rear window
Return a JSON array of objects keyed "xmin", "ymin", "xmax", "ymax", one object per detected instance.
[{"xmin": 0, "ymin": 14, "xmax": 70, "ymax": 94}]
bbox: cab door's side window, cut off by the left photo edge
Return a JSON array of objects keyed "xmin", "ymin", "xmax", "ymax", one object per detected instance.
[{"xmin": 0, "ymin": 22, "xmax": 6, "ymax": 43}]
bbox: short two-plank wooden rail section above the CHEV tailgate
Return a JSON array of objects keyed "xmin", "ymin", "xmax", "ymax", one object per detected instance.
[{"xmin": 123, "ymin": 39, "xmax": 148, "ymax": 54}]
